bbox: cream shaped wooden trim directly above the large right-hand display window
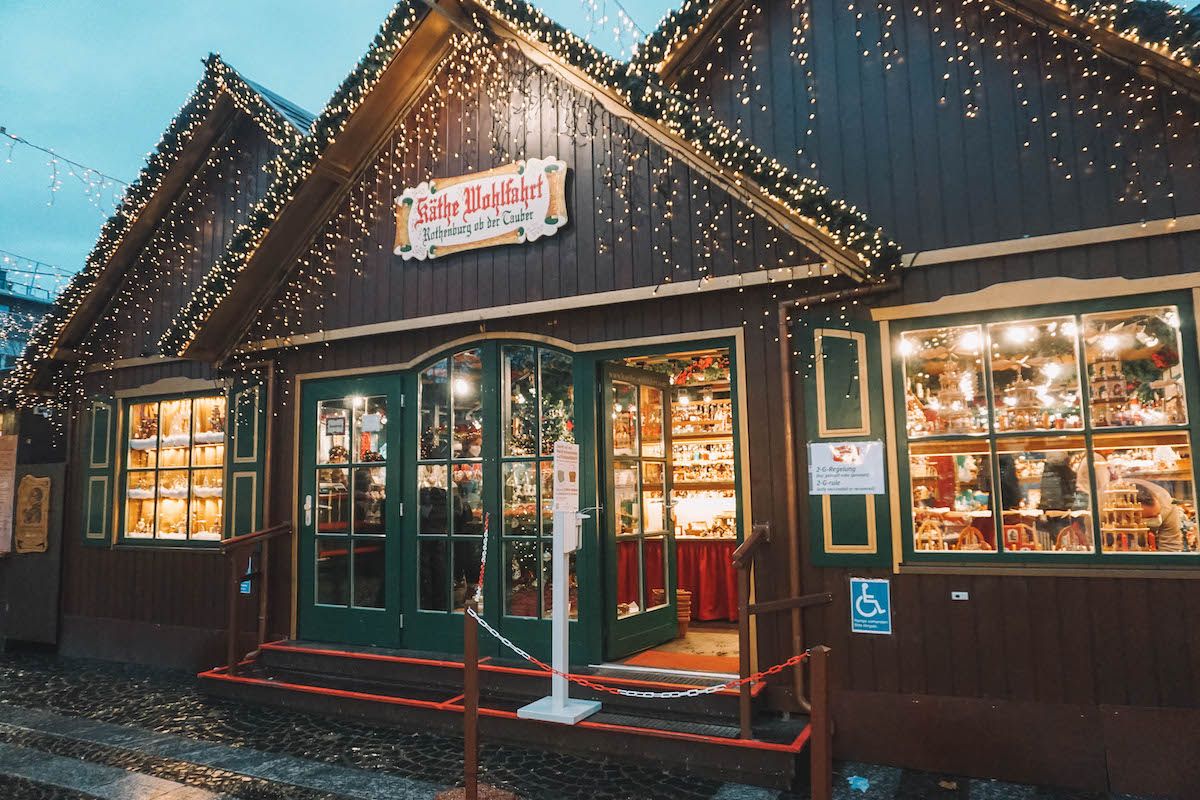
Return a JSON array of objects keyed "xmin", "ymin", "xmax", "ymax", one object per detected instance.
[{"xmin": 871, "ymin": 272, "xmax": 1200, "ymax": 320}]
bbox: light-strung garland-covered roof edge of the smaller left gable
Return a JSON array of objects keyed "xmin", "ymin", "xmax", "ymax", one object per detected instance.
[{"xmin": 5, "ymin": 54, "xmax": 311, "ymax": 392}]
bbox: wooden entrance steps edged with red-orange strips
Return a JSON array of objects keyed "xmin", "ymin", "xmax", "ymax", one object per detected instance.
[{"xmin": 199, "ymin": 642, "xmax": 809, "ymax": 788}]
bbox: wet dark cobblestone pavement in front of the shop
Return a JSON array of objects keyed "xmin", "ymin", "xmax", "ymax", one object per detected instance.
[{"xmin": 0, "ymin": 652, "xmax": 1161, "ymax": 800}]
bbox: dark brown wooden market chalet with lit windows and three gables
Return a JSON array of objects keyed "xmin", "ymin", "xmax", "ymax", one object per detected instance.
[{"xmin": 0, "ymin": 0, "xmax": 1200, "ymax": 795}]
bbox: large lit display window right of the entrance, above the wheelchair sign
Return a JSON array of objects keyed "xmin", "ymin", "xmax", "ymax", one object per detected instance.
[{"xmin": 893, "ymin": 299, "xmax": 1200, "ymax": 561}]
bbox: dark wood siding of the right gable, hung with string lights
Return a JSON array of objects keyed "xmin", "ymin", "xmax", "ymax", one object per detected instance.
[{"xmin": 680, "ymin": 0, "xmax": 1200, "ymax": 252}]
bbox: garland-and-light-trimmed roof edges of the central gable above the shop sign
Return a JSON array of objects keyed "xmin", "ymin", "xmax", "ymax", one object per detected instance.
[{"xmin": 160, "ymin": 0, "xmax": 900, "ymax": 359}]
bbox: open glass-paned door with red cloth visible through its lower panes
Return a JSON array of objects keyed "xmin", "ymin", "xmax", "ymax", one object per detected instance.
[{"xmin": 600, "ymin": 365, "xmax": 678, "ymax": 658}]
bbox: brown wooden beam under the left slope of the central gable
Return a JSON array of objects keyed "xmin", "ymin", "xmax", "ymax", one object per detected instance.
[{"xmin": 184, "ymin": 4, "xmax": 455, "ymax": 361}]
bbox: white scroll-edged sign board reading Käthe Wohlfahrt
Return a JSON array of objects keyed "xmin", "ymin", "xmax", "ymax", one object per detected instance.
[{"xmin": 395, "ymin": 158, "xmax": 566, "ymax": 261}]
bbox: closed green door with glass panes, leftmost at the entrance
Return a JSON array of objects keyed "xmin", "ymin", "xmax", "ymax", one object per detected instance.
[{"xmin": 298, "ymin": 375, "xmax": 403, "ymax": 646}]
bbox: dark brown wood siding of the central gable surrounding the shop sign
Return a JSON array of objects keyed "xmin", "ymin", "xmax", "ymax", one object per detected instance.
[{"xmin": 250, "ymin": 43, "xmax": 812, "ymax": 341}]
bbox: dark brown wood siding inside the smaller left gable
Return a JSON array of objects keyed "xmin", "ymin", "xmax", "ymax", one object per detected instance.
[{"xmin": 89, "ymin": 114, "xmax": 278, "ymax": 359}]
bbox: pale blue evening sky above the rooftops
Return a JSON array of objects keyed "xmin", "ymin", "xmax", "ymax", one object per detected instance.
[{"xmin": 0, "ymin": 0, "xmax": 677, "ymax": 287}]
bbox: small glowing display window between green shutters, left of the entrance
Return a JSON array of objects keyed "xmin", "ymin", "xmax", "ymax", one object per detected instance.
[{"xmin": 121, "ymin": 395, "xmax": 226, "ymax": 543}]
